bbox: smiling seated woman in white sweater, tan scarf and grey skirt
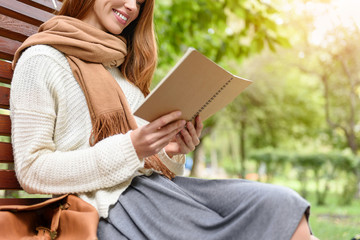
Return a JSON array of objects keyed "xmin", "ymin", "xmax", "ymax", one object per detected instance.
[{"xmin": 11, "ymin": 0, "xmax": 312, "ymax": 240}]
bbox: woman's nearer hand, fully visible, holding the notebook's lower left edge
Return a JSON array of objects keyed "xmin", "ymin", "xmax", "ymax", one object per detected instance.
[{"xmin": 130, "ymin": 111, "xmax": 186, "ymax": 159}]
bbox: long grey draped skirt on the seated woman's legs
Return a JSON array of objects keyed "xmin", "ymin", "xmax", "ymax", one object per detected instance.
[{"xmin": 98, "ymin": 174, "xmax": 309, "ymax": 240}]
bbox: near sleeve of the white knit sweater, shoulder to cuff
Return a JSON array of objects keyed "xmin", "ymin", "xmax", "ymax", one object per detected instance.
[{"xmin": 10, "ymin": 47, "xmax": 144, "ymax": 194}]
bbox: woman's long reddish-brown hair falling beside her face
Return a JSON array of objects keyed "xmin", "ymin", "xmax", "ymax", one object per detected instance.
[{"xmin": 58, "ymin": 0, "xmax": 157, "ymax": 96}]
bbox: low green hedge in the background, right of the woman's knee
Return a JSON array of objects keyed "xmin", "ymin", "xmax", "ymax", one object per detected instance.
[{"xmin": 249, "ymin": 148, "xmax": 360, "ymax": 205}]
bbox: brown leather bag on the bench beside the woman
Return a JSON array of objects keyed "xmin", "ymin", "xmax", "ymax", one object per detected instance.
[{"xmin": 0, "ymin": 195, "xmax": 99, "ymax": 240}]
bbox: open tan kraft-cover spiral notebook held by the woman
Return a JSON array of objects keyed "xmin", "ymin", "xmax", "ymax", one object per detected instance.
[{"xmin": 134, "ymin": 48, "xmax": 252, "ymax": 122}]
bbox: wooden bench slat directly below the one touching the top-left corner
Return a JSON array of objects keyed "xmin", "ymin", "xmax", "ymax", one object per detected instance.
[{"xmin": 0, "ymin": 14, "xmax": 38, "ymax": 42}]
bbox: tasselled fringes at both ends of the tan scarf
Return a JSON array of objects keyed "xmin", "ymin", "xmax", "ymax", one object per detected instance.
[{"xmin": 89, "ymin": 112, "xmax": 175, "ymax": 179}]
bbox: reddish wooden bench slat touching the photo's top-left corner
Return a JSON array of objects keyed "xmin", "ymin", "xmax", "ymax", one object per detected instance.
[{"xmin": 0, "ymin": 0, "xmax": 53, "ymax": 26}]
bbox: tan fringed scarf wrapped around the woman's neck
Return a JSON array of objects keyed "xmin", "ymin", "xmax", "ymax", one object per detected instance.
[{"xmin": 13, "ymin": 16, "xmax": 174, "ymax": 179}]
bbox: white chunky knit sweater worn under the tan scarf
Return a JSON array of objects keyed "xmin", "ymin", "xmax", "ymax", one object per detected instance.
[{"xmin": 10, "ymin": 45, "xmax": 185, "ymax": 217}]
